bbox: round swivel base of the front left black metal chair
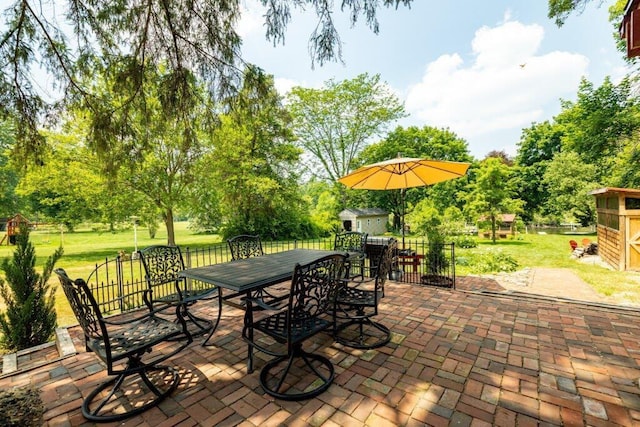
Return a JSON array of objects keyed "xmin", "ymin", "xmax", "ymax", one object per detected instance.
[{"xmin": 82, "ymin": 365, "xmax": 180, "ymax": 422}]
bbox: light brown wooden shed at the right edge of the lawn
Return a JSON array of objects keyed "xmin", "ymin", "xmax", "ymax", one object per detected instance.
[{"xmin": 589, "ymin": 187, "xmax": 640, "ymax": 271}]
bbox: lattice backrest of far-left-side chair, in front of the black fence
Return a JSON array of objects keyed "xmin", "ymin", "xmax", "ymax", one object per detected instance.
[{"xmin": 140, "ymin": 245, "xmax": 184, "ymax": 298}]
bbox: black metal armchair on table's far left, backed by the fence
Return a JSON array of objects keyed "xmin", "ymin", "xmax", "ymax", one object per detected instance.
[{"xmin": 140, "ymin": 245, "xmax": 222, "ymax": 346}]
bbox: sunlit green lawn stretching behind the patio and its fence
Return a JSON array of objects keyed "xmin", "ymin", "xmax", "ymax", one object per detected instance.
[{"xmin": 0, "ymin": 222, "xmax": 640, "ymax": 325}]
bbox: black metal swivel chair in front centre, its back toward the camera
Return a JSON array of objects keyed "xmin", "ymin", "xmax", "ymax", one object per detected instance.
[{"xmin": 242, "ymin": 254, "xmax": 347, "ymax": 400}]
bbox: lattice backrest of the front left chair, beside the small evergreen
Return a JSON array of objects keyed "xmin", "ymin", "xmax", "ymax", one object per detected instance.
[{"xmin": 55, "ymin": 268, "xmax": 108, "ymax": 347}]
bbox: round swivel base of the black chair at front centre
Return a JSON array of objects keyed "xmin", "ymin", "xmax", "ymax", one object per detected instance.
[{"xmin": 260, "ymin": 344, "xmax": 335, "ymax": 401}]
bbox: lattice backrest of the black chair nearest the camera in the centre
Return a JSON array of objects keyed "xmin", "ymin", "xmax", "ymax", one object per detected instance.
[{"xmin": 288, "ymin": 254, "xmax": 347, "ymax": 332}]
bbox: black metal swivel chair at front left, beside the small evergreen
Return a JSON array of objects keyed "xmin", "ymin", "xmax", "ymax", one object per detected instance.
[{"xmin": 55, "ymin": 268, "xmax": 192, "ymax": 422}]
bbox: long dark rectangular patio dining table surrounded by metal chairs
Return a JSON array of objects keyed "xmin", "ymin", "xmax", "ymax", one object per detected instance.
[{"xmin": 180, "ymin": 249, "xmax": 344, "ymax": 373}]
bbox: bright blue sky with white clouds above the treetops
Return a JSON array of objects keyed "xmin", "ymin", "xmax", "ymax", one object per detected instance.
[{"xmin": 239, "ymin": 0, "xmax": 627, "ymax": 158}]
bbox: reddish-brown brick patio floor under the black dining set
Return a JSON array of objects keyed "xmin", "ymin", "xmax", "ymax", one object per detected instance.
[{"xmin": 0, "ymin": 277, "xmax": 640, "ymax": 427}]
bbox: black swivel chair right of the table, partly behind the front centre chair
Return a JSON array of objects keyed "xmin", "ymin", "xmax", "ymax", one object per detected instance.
[{"xmin": 333, "ymin": 239, "xmax": 397, "ymax": 349}]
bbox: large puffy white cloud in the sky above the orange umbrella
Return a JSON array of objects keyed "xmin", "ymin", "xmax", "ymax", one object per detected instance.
[{"xmin": 405, "ymin": 19, "xmax": 589, "ymax": 151}]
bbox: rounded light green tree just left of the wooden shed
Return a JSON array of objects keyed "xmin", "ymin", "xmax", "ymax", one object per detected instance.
[{"xmin": 543, "ymin": 152, "xmax": 600, "ymax": 226}]
